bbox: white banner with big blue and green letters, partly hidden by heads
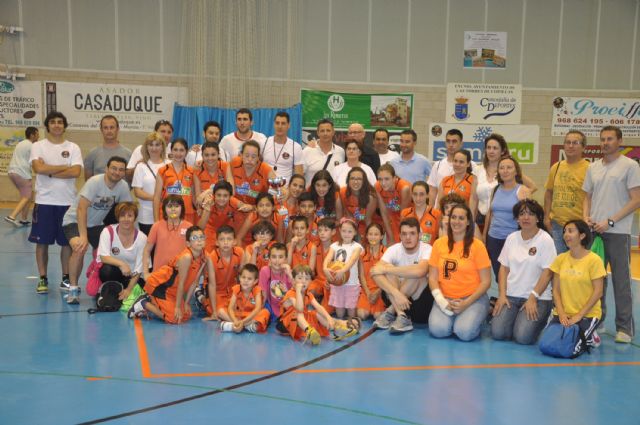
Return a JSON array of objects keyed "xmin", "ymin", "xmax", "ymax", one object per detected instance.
[{"xmin": 429, "ymin": 123, "xmax": 540, "ymax": 165}]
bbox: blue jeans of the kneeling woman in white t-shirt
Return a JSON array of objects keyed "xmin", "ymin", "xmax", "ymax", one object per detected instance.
[{"xmin": 491, "ymin": 297, "xmax": 553, "ymax": 345}]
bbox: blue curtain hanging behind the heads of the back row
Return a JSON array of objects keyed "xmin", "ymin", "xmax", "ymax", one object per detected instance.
[{"xmin": 172, "ymin": 103, "xmax": 302, "ymax": 146}]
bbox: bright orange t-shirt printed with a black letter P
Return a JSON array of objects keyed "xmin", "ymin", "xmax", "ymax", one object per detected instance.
[{"xmin": 429, "ymin": 236, "xmax": 491, "ymax": 299}]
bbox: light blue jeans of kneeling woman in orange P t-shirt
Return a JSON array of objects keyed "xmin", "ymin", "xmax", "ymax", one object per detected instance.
[{"xmin": 429, "ymin": 294, "xmax": 489, "ymax": 341}]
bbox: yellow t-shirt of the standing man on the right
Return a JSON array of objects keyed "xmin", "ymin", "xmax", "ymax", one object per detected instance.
[{"xmin": 544, "ymin": 160, "xmax": 589, "ymax": 226}]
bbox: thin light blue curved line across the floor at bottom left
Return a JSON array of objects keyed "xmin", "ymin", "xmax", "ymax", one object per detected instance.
[{"xmin": 0, "ymin": 370, "xmax": 420, "ymax": 425}]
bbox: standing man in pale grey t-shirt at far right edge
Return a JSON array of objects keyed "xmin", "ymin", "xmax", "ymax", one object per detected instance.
[{"xmin": 582, "ymin": 126, "xmax": 640, "ymax": 344}]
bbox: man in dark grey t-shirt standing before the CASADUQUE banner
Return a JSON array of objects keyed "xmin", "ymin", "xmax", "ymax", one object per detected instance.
[{"xmin": 84, "ymin": 115, "xmax": 131, "ymax": 181}]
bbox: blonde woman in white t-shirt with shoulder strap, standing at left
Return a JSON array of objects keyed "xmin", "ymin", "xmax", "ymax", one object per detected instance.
[{"xmin": 131, "ymin": 131, "xmax": 166, "ymax": 235}]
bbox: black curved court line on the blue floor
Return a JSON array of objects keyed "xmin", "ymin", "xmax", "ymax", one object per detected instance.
[{"xmin": 79, "ymin": 327, "xmax": 376, "ymax": 425}]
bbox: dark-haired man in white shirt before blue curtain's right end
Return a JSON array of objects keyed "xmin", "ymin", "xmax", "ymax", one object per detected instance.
[{"xmin": 262, "ymin": 111, "xmax": 304, "ymax": 184}]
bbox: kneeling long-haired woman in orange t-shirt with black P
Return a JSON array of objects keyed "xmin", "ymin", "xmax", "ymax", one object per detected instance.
[{"xmin": 429, "ymin": 204, "xmax": 491, "ymax": 341}]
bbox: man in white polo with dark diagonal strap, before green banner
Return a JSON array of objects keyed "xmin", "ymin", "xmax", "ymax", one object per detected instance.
[{"xmin": 302, "ymin": 118, "xmax": 345, "ymax": 187}]
